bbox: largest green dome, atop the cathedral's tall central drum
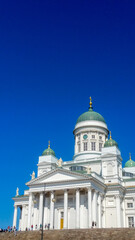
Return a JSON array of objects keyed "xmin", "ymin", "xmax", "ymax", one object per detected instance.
[{"xmin": 76, "ymin": 108, "xmax": 106, "ymax": 123}]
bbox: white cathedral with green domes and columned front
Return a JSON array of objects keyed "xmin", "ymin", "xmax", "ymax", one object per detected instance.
[{"xmin": 13, "ymin": 98, "xmax": 135, "ymax": 230}]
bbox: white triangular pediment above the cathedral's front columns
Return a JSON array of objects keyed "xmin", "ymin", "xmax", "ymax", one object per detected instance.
[{"xmin": 26, "ymin": 169, "xmax": 88, "ymax": 185}]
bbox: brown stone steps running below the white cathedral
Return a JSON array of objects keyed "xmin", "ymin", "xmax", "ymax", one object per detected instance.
[{"xmin": 0, "ymin": 228, "xmax": 135, "ymax": 240}]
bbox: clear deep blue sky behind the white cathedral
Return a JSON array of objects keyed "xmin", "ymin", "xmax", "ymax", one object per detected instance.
[{"xmin": 0, "ymin": 0, "xmax": 135, "ymax": 227}]
